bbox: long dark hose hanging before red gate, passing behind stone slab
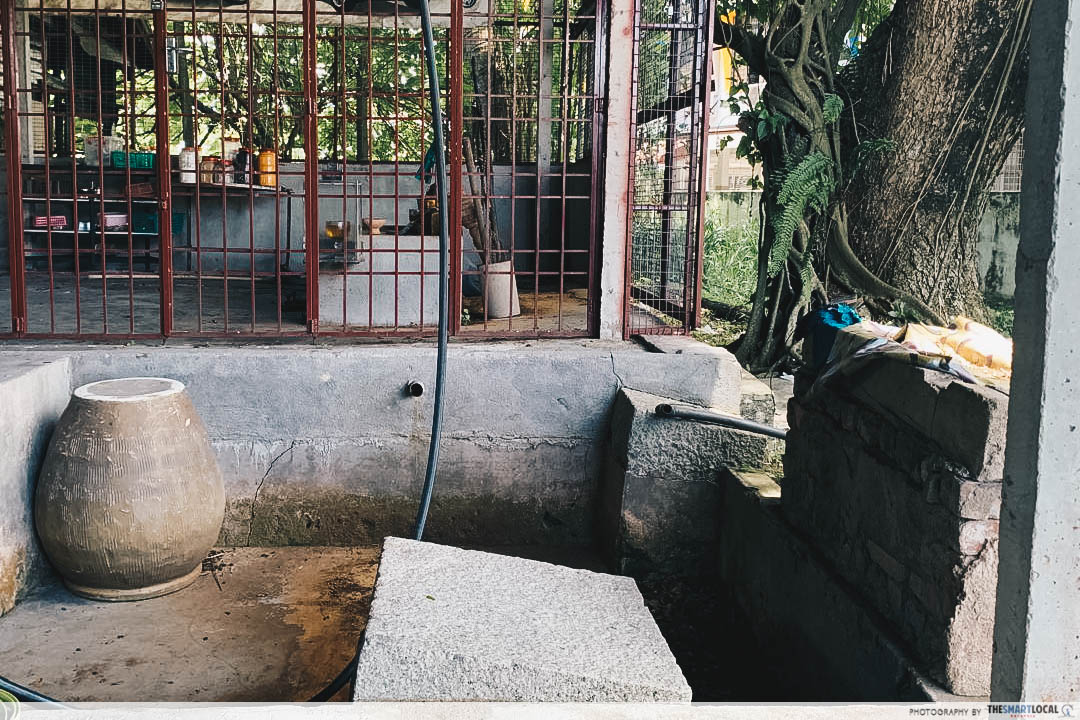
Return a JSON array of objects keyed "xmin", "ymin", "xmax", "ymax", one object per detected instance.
[{"xmin": 310, "ymin": 0, "xmax": 450, "ymax": 703}]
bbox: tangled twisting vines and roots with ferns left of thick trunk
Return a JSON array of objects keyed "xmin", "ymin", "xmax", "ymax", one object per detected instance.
[{"xmin": 715, "ymin": 0, "xmax": 972, "ymax": 371}]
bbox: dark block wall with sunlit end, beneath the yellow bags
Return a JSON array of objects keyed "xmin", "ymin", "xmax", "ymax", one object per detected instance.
[{"xmin": 783, "ymin": 361, "xmax": 1008, "ymax": 696}]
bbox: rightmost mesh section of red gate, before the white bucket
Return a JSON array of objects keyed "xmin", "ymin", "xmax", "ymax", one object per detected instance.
[{"xmin": 460, "ymin": 0, "xmax": 603, "ymax": 335}]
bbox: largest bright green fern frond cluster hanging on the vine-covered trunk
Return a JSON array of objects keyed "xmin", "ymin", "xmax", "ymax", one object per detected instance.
[{"xmin": 769, "ymin": 152, "xmax": 834, "ymax": 277}]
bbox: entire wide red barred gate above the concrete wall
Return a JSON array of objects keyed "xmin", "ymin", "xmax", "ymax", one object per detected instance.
[{"xmin": 0, "ymin": 0, "xmax": 605, "ymax": 339}]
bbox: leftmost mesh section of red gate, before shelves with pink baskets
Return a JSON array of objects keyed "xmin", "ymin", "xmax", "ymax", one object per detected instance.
[{"xmin": 6, "ymin": 0, "xmax": 162, "ymax": 337}]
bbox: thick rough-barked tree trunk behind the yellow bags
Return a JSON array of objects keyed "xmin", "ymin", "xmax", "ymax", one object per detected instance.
[{"xmin": 840, "ymin": 0, "xmax": 1031, "ymax": 317}]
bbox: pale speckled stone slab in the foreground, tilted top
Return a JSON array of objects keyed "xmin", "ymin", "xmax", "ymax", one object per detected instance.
[{"xmin": 354, "ymin": 538, "xmax": 690, "ymax": 702}]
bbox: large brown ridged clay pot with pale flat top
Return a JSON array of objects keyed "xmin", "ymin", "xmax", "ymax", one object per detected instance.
[{"xmin": 33, "ymin": 378, "xmax": 225, "ymax": 600}]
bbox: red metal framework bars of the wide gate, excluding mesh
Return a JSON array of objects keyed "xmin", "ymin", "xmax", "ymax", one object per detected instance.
[{"xmin": 0, "ymin": 0, "xmax": 608, "ymax": 341}]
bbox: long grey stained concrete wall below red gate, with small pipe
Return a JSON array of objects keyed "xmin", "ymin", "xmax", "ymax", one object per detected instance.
[{"xmin": 0, "ymin": 341, "xmax": 739, "ymax": 569}]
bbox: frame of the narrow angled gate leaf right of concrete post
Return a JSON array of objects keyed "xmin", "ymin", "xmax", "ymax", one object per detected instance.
[{"xmin": 623, "ymin": 0, "xmax": 715, "ymax": 339}]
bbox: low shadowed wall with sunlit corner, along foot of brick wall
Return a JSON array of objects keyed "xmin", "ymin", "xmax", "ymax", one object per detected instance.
[{"xmin": 716, "ymin": 472, "xmax": 944, "ymax": 702}]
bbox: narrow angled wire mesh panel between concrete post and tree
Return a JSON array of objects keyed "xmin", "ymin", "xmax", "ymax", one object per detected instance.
[{"xmin": 625, "ymin": 0, "xmax": 712, "ymax": 335}]
